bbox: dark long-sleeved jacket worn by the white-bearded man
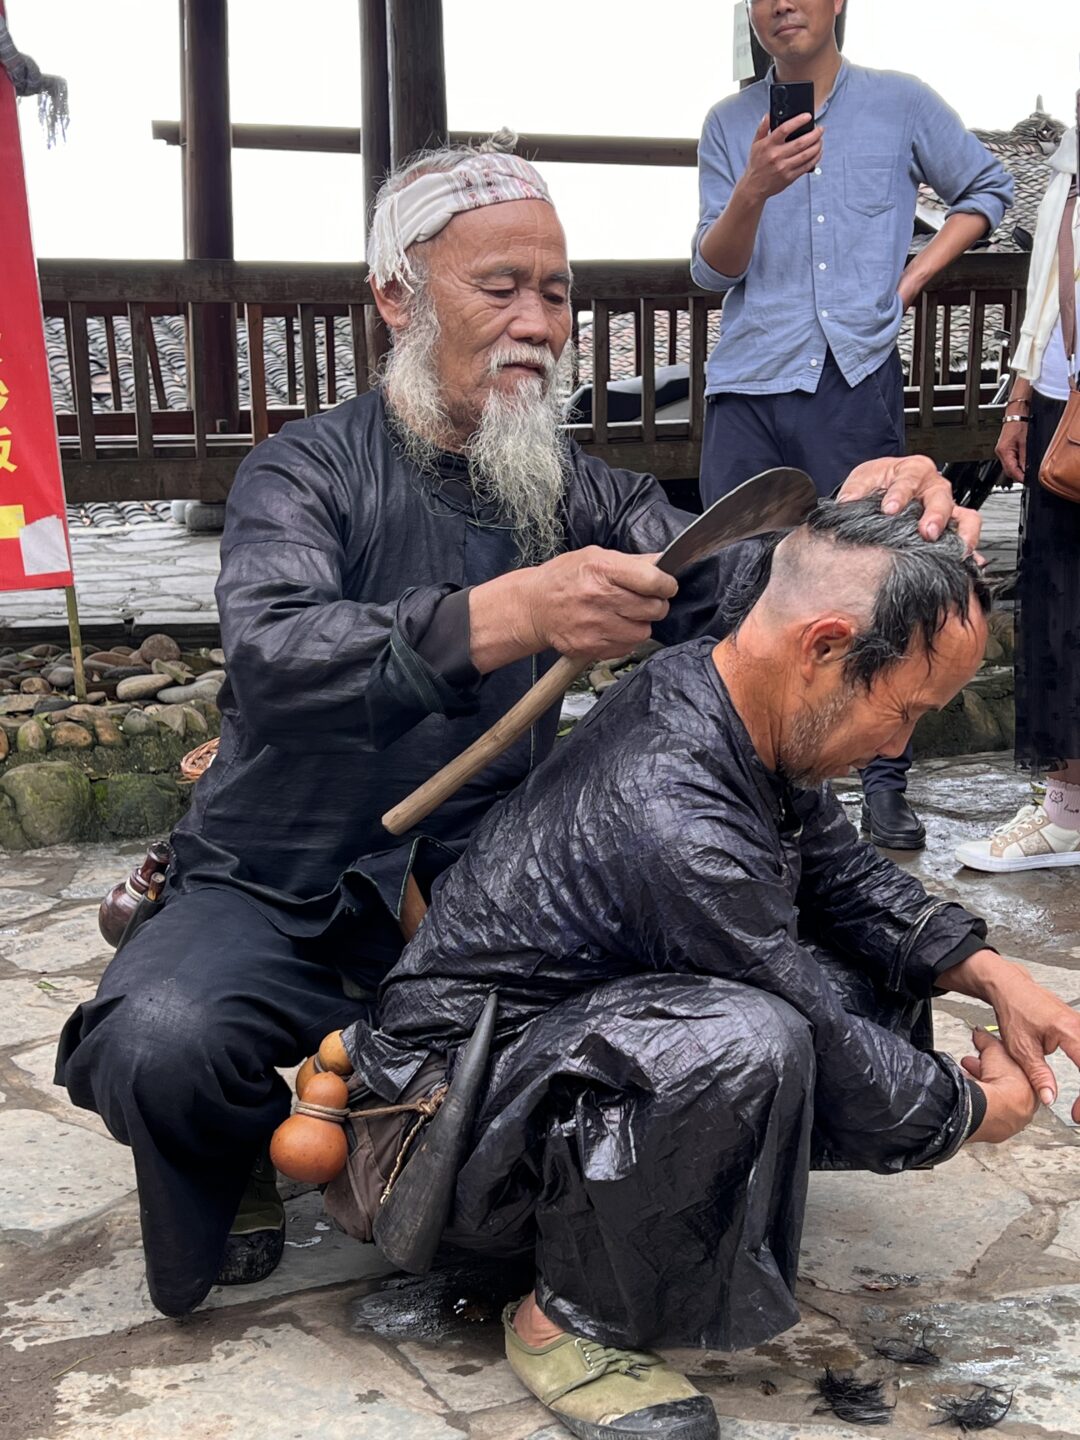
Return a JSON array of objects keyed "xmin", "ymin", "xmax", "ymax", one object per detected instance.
[{"xmin": 171, "ymin": 392, "xmax": 756, "ymax": 984}]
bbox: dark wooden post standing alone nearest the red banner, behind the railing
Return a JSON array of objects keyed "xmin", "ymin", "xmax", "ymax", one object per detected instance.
[{"xmin": 184, "ymin": 0, "xmax": 239, "ymax": 431}]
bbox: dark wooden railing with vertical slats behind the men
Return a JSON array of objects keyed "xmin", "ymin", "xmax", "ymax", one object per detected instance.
[{"xmin": 40, "ymin": 253, "xmax": 1027, "ymax": 501}]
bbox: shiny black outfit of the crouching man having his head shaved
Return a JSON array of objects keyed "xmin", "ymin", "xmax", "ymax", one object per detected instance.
[{"xmin": 346, "ymin": 639, "xmax": 985, "ymax": 1348}]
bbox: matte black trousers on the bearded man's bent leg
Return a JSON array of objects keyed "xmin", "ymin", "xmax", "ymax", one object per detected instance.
[{"xmin": 56, "ymin": 890, "xmax": 377, "ymax": 1315}]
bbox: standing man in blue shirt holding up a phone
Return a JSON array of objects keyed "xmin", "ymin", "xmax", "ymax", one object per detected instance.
[{"xmin": 691, "ymin": 0, "xmax": 1012, "ymax": 850}]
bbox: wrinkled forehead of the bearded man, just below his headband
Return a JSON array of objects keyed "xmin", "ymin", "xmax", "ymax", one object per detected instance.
[{"xmin": 410, "ymin": 200, "xmax": 572, "ymax": 295}]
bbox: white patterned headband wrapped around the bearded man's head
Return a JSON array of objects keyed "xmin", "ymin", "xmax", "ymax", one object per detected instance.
[{"xmin": 367, "ymin": 150, "xmax": 552, "ymax": 289}]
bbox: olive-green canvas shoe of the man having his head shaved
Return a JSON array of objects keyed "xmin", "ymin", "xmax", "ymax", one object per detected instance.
[{"xmin": 503, "ymin": 1302, "xmax": 720, "ymax": 1440}]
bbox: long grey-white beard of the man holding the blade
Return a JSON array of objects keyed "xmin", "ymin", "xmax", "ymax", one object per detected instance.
[{"xmin": 383, "ymin": 295, "xmax": 567, "ymax": 564}]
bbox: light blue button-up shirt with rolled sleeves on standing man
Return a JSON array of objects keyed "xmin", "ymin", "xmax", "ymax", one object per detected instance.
[{"xmin": 690, "ymin": 60, "xmax": 1012, "ymax": 395}]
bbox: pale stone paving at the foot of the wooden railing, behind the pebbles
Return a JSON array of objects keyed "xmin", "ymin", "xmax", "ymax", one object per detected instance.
[{"xmin": 0, "ymin": 490, "xmax": 1020, "ymax": 645}]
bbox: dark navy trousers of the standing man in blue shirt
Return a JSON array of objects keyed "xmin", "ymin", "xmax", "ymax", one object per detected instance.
[{"xmin": 701, "ymin": 350, "xmax": 912, "ymax": 796}]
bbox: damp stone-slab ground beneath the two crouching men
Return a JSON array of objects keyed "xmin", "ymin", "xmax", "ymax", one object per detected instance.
[{"xmin": 0, "ymin": 756, "xmax": 1080, "ymax": 1440}]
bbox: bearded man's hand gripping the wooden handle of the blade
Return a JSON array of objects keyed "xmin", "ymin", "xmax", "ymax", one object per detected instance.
[{"xmin": 523, "ymin": 544, "xmax": 678, "ymax": 661}]
